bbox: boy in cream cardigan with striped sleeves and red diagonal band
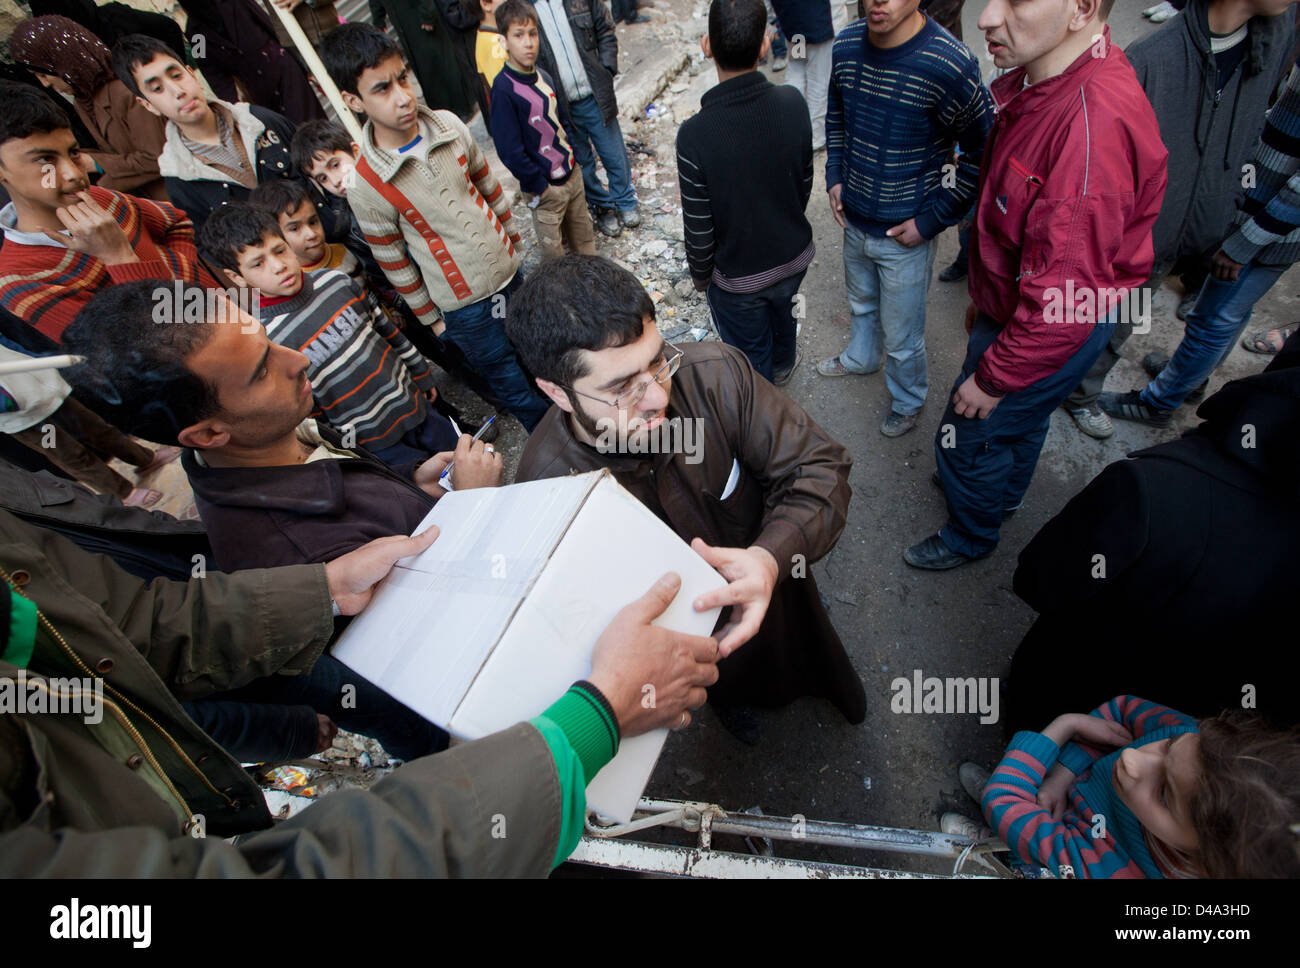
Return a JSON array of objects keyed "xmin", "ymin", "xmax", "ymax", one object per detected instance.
[{"xmin": 320, "ymin": 23, "xmax": 546, "ymax": 431}]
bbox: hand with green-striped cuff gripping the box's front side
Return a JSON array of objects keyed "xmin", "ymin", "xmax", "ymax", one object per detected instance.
[{"xmin": 588, "ymin": 572, "xmax": 719, "ymax": 737}]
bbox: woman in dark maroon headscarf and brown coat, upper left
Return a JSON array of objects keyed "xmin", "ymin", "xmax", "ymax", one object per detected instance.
[{"xmin": 9, "ymin": 17, "xmax": 166, "ymax": 201}]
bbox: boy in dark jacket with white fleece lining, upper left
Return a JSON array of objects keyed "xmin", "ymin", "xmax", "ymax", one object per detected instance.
[{"xmin": 113, "ymin": 34, "xmax": 294, "ymax": 226}]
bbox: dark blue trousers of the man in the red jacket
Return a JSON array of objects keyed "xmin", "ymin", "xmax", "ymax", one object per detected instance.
[{"xmin": 935, "ymin": 313, "xmax": 1115, "ymax": 557}]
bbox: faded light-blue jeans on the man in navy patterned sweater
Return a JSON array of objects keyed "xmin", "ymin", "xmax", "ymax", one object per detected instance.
[{"xmin": 840, "ymin": 225, "xmax": 935, "ymax": 417}]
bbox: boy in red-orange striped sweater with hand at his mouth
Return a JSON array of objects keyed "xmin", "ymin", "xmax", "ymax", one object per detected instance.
[{"xmin": 0, "ymin": 81, "xmax": 216, "ymax": 342}]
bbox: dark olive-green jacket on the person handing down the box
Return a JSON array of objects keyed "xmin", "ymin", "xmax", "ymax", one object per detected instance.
[{"xmin": 0, "ymin": 512, "xmax": 562, "ymax": 877}]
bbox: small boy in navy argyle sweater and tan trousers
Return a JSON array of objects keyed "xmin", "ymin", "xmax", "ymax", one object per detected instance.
[{"xmin": 491, "ymin": 0, "xmax": 595, "ymax": 256}]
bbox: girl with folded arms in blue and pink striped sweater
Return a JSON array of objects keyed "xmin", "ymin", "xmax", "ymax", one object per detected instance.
[{"xmin": 967, "ymin": 695, "xmax": 1300, "ymax": 877}]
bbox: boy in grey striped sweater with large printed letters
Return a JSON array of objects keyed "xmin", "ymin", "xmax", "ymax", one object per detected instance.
[{"xmin": 199, "ymin": 201, "xmax": 458, "ymax": 464}]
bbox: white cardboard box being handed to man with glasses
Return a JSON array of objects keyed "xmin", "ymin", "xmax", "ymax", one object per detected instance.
[{"xmin": 333, "ymin": 470, "xmax": 725, "ymax": 821}]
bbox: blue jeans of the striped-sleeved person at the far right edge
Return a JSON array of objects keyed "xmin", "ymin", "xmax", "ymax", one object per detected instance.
[{"xmin": 1141, "ymin": 262, "xmax": 1290, "ymax": 411}]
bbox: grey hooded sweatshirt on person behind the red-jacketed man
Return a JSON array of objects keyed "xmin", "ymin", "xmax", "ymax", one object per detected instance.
[{"xmin": 1125, "ymin": 0, "xmax": 1295, "ymax": 279}]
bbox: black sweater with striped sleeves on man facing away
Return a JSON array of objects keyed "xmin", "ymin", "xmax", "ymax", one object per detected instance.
[{"xmin": 677, "ymin": 71, "xmax": 813, "ymax": 292}]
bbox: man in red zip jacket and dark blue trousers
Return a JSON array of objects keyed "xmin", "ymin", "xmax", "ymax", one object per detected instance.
[{"xmin": 904, "ymin": 0, "xmax": 1167, "ymax": 570}]
